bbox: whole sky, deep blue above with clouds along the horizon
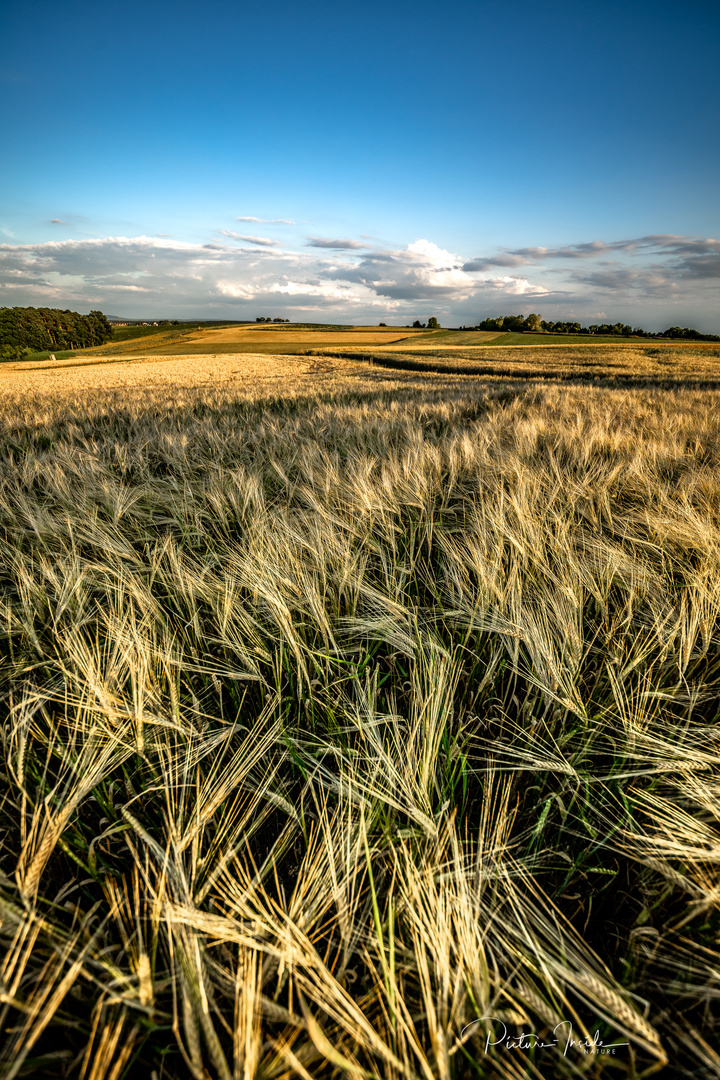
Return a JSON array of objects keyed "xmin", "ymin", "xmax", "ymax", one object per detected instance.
[{"xmin": 0, "ymin": 0, "xmax": 720, "ymax": 333}]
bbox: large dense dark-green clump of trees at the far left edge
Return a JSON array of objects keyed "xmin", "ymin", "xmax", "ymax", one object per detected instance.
[{"xmin": 0, "ymin": 308, "xmax": 112, "ymax": 353}]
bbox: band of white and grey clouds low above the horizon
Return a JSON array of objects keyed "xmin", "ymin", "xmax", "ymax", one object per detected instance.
[{"xmin": 0, "ymin": 230, "xmax": 720, "ymax": 329}]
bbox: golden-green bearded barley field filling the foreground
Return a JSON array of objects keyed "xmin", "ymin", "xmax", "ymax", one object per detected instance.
[{"xmin": 0, "ymin": 350, "xmax": 720, "ymax": 1080}]
